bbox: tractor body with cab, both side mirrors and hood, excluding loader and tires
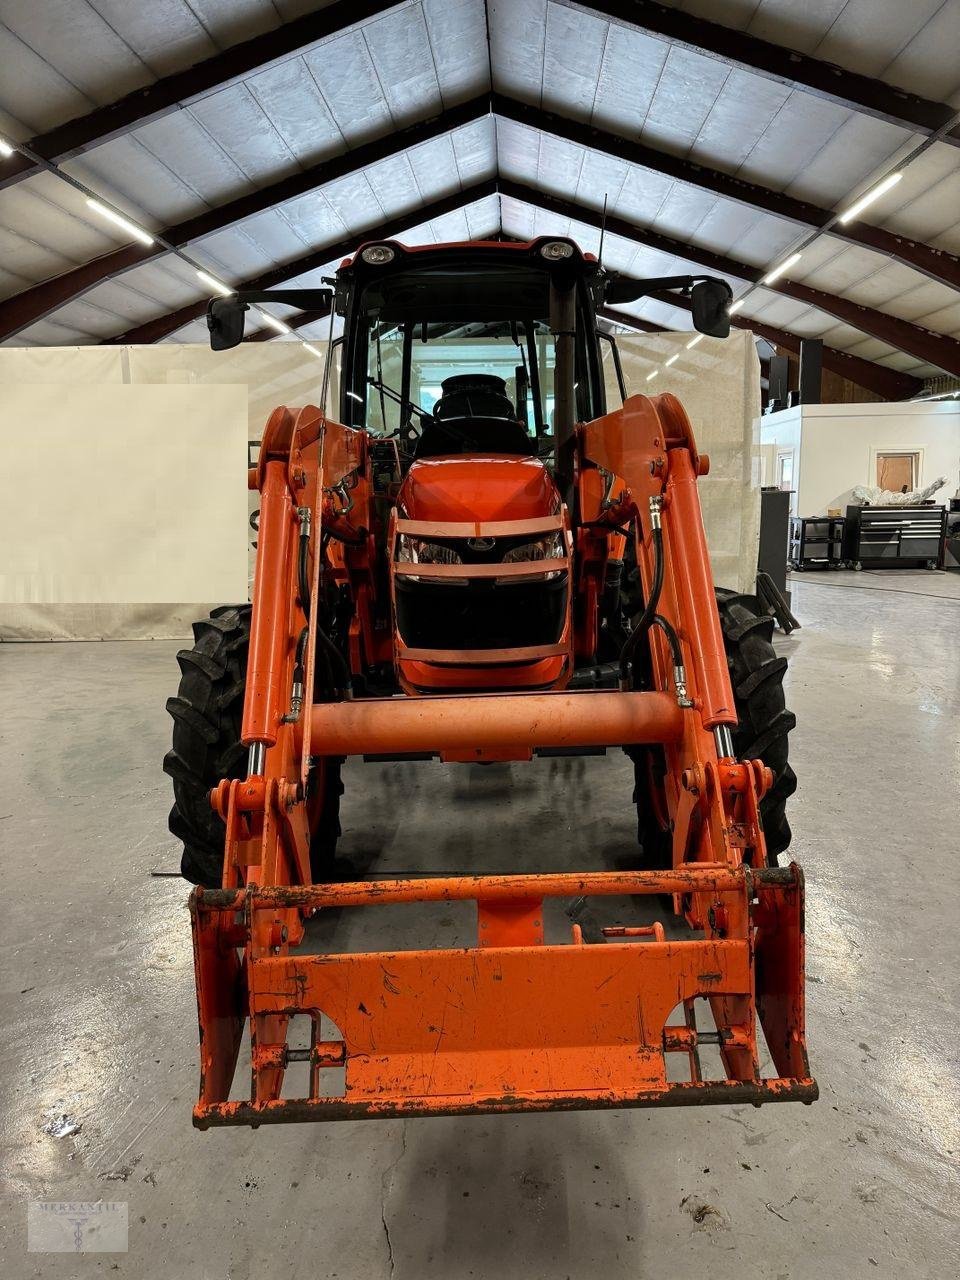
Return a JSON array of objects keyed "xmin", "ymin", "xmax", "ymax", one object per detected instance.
[{"xmin": 200, "ymin": 237, "xmax": 730, "ymax": 696}]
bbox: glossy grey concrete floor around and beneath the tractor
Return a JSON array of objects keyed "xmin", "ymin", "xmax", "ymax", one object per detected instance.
[{"xmin": 0, "ymin": 572, "xmax": 960, "ymax": 1280}]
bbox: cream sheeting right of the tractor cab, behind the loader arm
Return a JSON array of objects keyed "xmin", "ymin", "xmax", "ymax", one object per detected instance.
[{"xmin": 603, "ymin": 330, "xmax": 760, "ymax": 591}]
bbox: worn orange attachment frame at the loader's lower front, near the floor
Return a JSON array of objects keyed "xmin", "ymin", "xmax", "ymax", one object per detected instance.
[{"xmin": 191, "ymin": 864, "xmax": 817, "ymax": 1128}]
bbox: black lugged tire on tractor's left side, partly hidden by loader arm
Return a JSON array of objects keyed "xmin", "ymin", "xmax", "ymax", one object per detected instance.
[{"xmin": 164, "ymin": 604, "xmax": 343, "ymax": 888}]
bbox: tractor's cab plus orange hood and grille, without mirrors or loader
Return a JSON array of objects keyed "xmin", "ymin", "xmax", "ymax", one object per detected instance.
[{"xmin": 337, "ymin": 241, "xmax": 604, "ymax": 695}]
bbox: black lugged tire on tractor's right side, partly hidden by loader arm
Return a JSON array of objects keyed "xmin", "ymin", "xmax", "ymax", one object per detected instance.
[{"xmin": 630, "ymin": 588, "xmax": 796, "ymax": 868}]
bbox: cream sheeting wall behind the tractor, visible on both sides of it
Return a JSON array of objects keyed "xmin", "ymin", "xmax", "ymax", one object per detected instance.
[{"xmin": 0, "ymin": 333, "xmax": 760, "ymax": 639}]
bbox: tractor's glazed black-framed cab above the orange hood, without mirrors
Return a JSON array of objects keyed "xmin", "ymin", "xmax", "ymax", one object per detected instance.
[{"xmin": 337, "ymin": 239, "xmax": 605, "ymax": 465}]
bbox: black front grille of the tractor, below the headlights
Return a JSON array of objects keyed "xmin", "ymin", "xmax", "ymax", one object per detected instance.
[{"xmin": 397, "ymin": 573, "xmax": 567, "ymax": 649}]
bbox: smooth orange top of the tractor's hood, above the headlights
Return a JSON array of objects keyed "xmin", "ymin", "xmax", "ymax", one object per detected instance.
[{"xmin": 399, "ymin": 453, "xmax": 561, "ymax": 522}]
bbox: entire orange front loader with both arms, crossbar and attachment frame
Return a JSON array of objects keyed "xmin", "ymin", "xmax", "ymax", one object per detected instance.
[{"xmin": 191, "ymin": 396, "xmax": 818, "ymax": 1128}]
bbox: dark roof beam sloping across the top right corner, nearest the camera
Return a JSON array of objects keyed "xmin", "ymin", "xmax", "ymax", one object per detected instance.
[{"xmin": 568, "ymin": 0, "xmax": 960, "ymax": 146}]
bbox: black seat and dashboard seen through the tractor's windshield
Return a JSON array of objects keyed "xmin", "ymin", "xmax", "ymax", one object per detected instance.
[{"xmin": 415, "ymin": 374, "xmax": 536, "ymax": 458}]
